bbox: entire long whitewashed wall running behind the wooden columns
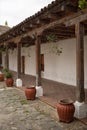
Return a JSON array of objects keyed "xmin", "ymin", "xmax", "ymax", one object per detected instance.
[{"xmin": 3, "ymin": 37, "xmax": 87, "ymax": 88}]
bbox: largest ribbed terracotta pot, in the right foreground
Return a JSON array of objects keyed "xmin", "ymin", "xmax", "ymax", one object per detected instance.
[{"xmin": 57, "ymin": 99, "xmax": 75, "ymax": 123}]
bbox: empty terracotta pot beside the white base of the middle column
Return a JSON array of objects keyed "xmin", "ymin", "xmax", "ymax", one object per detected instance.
[{"xmin": 25, "ymin": 87, "xmax": 36, "ymax": 100}]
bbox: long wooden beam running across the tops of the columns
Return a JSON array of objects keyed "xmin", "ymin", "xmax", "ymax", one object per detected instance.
[{"xmin": 0, "ymin": 9, "xmax": 87, "ymax": 42}]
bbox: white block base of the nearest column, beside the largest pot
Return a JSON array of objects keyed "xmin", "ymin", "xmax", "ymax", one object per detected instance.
[{"xmin": 74, "ymin": 101, "xmax": 87, "ymax": 118}]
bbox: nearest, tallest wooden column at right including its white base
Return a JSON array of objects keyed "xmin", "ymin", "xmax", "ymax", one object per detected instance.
[{"xmin": 75, "ymin": 23, "xmax": 87, "ymax": 118}]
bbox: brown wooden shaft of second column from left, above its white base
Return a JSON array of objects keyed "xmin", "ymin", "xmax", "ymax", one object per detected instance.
[{"xmin": 17, "ymin": 43, "xmax": 21, "ymax": 78}]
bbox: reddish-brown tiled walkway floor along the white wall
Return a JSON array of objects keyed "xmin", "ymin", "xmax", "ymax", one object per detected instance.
[{"xmin": 14, "ymin": 72, "xmax": 87, "ymax": 107}]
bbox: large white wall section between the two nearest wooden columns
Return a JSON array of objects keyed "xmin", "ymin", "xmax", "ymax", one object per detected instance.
[{"xmin": 42, "ymin": 39, "xmax": 76, "ymax": 85}]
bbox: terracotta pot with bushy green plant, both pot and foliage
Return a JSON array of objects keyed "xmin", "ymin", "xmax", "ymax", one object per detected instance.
[{"xmin": 5, "ymin": 71, "xmax": 14, "ymax": 87}]
